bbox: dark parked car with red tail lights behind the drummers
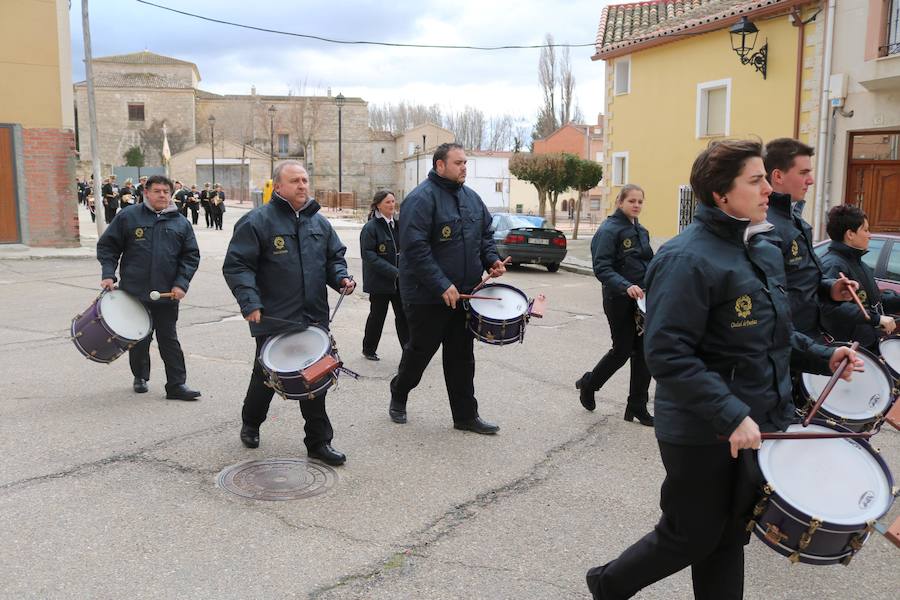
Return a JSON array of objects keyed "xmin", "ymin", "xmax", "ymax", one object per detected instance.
[{"xmin": 491, "ymin": 213, "xmax": 566, "ymax": 273}]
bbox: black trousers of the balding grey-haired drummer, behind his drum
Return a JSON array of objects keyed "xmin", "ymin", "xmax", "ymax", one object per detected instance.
[{"xmin": 241, "ymin": 336, "xmax": 334, "ymax": 450}]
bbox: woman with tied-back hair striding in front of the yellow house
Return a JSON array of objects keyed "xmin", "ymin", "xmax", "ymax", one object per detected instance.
[{"xmin": 575, "ymin": 183, "xmax": 653, "ymax": 427}]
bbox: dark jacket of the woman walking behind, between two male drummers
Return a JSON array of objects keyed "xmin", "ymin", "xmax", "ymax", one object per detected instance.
[{"xmin": 359, "ymin": 216, "xmax": 400, "ymax": 294}]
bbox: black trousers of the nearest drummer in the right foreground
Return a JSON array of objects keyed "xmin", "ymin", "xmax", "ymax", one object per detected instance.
[{"xmin": 587, "ymin": 442, "xmax": 756, "ymax": 600}]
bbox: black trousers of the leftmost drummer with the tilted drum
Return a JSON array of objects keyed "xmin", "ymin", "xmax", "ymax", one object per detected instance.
[{"xmin": 128, "ymin": 302, "xmax": 187, "ymax": 389}]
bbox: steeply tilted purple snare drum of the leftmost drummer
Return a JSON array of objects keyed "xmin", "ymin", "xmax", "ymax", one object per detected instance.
[{"xmin": 70, "ymin": 290, "xmax": 153, "ymax": 363}]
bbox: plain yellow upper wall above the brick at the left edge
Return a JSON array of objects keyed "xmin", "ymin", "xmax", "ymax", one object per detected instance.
[{"xmin": 0, "ymin": 0, "xmax": 75, "ymax": 129}]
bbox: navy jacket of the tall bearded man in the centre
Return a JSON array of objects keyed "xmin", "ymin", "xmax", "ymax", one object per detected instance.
[{"xmin": 400, "ymin": 169, "xmax": 500, "ymax": 304}]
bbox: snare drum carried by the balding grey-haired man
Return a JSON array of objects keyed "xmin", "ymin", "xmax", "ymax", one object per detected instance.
[{"xmin": 258, "ymin": 325, "xmax": 342, "ymax": 400}]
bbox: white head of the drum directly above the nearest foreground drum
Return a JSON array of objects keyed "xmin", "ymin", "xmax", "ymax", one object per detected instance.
[{"xmin": 803, "ymin": 349, "xmax": 891, "ymax": 421}]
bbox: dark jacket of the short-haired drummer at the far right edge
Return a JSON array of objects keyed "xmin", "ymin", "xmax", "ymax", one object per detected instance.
[{"xmin": 822, "ymin": 241, "xmax": 900, "ymax": 349}]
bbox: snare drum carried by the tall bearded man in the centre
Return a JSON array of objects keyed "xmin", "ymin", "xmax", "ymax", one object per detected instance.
[{"xmin": 466, "ymin": 283, "xmax": 530, "ymax": 346}]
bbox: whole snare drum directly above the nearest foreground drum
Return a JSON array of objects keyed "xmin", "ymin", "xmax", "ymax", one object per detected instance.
[{"xmin": 796, "ymin": 348, "xmax": 894, "ymax": 431}]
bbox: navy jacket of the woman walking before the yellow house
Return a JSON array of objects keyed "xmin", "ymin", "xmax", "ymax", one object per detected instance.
[{"xmin": 591, "ymin": 210, "xmax": 653, "ymax": 298}]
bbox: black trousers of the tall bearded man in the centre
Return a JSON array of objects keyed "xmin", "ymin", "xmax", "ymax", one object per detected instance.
[{"xmin": 391, "ymin": 302, "xmax": 478, "ymax": 421}]
